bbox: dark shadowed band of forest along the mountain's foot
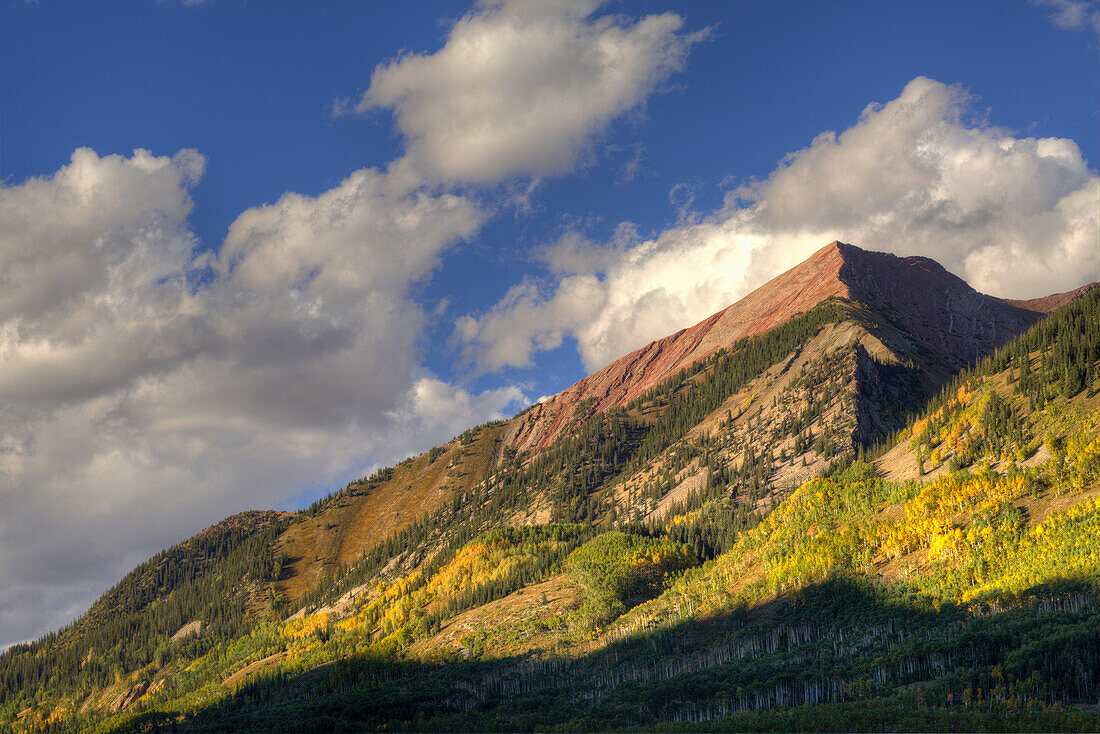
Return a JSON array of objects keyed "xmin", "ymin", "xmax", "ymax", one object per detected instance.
[{"xmin": 107, "ymin": 579, "xmax": 1100, "ymax": 732}]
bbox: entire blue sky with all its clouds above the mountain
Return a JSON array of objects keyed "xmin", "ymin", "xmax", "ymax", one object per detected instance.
[{"xmin": 0, "ymin": 0, "xmax": 1100, "ymax": 645}]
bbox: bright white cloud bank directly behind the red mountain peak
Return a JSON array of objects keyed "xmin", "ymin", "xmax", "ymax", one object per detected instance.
[{"xmin": 455, "ymin": 77, "xmax": 1100, "ymax": 371}]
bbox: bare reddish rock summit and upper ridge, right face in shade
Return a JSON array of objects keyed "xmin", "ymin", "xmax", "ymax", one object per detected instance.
[{"xmin": 506, "ymin": 242, "xmax": 1040, "ymax": 450}]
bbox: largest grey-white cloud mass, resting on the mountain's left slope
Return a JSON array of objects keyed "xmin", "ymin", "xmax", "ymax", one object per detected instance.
[{"xmin": 0, "ymin": 149, "xmax": 524, "ymax": 644}]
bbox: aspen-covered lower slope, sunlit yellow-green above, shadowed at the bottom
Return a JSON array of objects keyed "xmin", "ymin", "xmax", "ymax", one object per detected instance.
[{"xmin": 83, "ymin": 458, "xmax": 1100, "ymax": 731}]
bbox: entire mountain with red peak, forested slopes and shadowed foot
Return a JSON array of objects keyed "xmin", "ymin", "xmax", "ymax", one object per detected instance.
[{"xmin": 0, "ymin": 242, "xmax": 1100, "ymax": 731}]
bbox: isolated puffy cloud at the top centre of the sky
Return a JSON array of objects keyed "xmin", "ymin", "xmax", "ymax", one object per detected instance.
[{"xmin": 360, "ymin": 0, "xmax": 705, "ymax": 183}]
